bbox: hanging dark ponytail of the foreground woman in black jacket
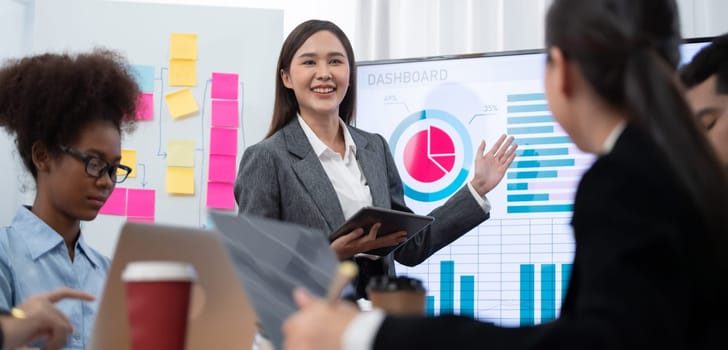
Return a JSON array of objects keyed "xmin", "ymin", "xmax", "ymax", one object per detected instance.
[{"xmin": 624, "ymin": 49, "xmax": 728, "ymax": 243}]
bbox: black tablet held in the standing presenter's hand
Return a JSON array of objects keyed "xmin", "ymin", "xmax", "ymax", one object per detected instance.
[{"xmin": 329, "ymin": 207, "xmax": 435, "ymax": 256}]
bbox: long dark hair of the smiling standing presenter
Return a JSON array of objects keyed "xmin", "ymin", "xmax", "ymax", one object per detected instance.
[{"xmin": 265, "ymin": 20, "xmax": 356, "ymax": 138}]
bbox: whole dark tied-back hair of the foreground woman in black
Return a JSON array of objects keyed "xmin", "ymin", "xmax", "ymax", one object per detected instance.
[{"xmin": 546, "ymin": 0, "xmax": 728, "ymax": 268}]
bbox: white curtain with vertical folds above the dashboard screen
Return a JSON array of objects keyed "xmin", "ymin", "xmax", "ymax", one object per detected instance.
[{"xmin": 354, "ymin": 0, "xmax": 728, "ymax": 60}]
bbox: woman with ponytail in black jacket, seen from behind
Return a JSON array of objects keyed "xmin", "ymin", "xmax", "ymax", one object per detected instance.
[{"xmin": 284, "ymin": 0, "xmax": 728, "ymax": 350}]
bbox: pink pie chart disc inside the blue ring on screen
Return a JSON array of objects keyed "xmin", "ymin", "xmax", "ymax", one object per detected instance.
[{"xmin": 403, "ymin": 125, "xmax": 455, "ymax": 183}]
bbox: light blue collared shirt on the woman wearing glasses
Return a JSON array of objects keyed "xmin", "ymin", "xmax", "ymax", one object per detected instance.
[{"xmin": 0, "ymin": 207, "xmax": 109, "ymax": 349}]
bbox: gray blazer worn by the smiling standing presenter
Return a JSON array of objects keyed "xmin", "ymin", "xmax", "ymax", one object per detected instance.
[{"xmin": 235, "ymin": 119, "xmax": 489, "ymax": 296}]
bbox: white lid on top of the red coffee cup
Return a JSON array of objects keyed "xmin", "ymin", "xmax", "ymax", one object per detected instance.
[{"xmin": 121, "ymin": 261, "xmax": 197, "ymax": 281}]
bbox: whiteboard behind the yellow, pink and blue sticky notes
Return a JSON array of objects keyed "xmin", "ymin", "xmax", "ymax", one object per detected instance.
[{"xmin": 0, "ymin": 0, "xmax": 283, "ymax": 256}]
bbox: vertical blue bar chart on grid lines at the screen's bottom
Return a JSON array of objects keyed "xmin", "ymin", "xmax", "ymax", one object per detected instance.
[{"xmin": 404, "ymin": 215, "xmax": 574, "ymax": 326}]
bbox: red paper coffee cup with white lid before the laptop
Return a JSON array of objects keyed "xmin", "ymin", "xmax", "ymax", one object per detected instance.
[{"xmin": 121, "ymin": 261, "xmax": 196, "ymax": 350}]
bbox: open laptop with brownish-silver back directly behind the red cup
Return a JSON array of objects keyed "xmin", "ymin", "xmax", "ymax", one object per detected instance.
[{"xmin": 90, "ymin": 223, "xmax": 257, "ymax": 350}]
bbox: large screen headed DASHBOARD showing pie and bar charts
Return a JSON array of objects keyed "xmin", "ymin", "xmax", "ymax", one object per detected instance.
[{"xmin": 356, "ymin": 39, "xmax": 707, "ymax": 326}]
